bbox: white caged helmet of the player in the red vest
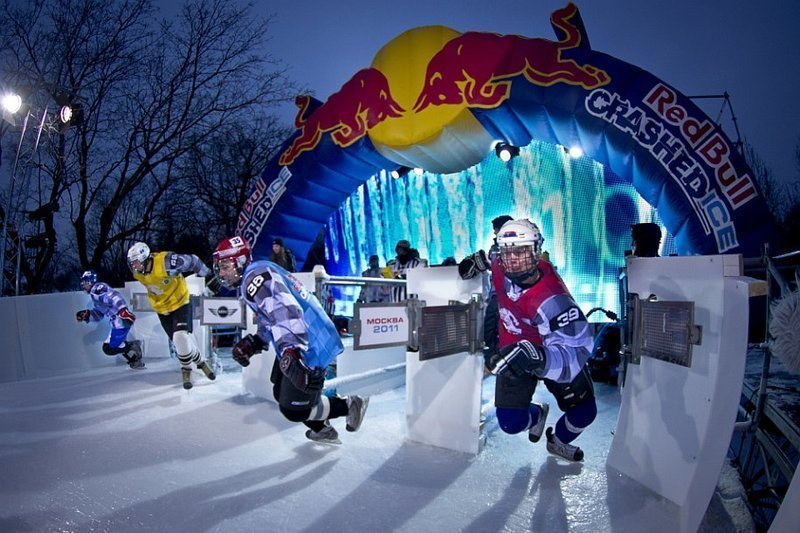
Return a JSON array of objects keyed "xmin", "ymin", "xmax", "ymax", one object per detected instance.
[{"xmin": 497, "ymin": 218, "xmax": 544, "ymax": 283}]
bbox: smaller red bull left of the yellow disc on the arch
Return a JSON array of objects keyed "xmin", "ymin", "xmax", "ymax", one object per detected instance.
[{"xmin": 279, "ymin": 68, "xmax": 405, "ymax": 165}]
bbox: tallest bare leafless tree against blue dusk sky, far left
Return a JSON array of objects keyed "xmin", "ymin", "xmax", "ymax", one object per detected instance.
[{"xmin": 0, "ymin": 0, "xmax": 294, "ymax": 292}]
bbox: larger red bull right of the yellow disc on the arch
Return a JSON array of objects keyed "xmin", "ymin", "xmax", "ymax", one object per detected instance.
[{"xmin": 414, "ymin": 3, "xmax": 610, "ymax": 112}]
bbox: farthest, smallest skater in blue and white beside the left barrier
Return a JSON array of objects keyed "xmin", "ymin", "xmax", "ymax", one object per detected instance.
[{"xmin": 75, "ymin": 270, "xmax": 144, "ymax": 369}]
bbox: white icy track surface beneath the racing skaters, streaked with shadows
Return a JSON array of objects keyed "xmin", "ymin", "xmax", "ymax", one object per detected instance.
[{"xmin": 0, "ymin": 359, "xmax": 752, "ymax": 533}]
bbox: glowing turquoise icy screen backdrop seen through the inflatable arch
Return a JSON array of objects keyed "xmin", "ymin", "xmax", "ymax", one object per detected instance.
[{"xmin": 326, "ymin": 142, "xmax": 673, "ymax": 320}]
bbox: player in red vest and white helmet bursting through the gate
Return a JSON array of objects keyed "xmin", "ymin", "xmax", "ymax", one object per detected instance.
[{"xmin": 460, "ymin": 219, "xmax": 597, "ymax": 461}]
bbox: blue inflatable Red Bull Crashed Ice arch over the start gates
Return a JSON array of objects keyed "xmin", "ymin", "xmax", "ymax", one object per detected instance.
[{"xmin": 238, "ymin": 3, "xmax": 773, "ymax": 264}]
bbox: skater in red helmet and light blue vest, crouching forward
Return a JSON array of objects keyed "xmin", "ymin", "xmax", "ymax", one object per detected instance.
[{"xmin": 214, "ymin": 236, "xmax": 369, "ymax": 444}]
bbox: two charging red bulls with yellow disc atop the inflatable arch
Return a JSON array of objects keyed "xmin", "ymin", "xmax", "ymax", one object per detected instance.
[{"xmin": 279, "ymin": 3, "xmax": 610, "ymax": 166}]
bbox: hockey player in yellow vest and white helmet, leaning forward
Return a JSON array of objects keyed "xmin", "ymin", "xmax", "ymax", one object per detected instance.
[{"xmin": 128, "ymin": 242, "xmax": 216, "ymax": 389}]
